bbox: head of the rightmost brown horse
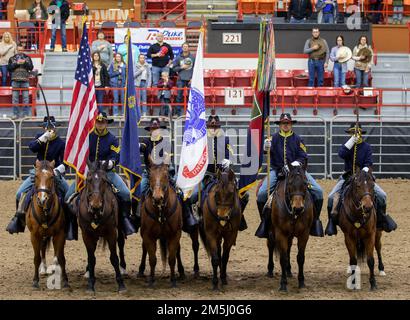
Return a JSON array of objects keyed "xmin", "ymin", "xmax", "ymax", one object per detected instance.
[{"xmin": 352, "ymin": 169, "xmax": 374, "ymax": 213}]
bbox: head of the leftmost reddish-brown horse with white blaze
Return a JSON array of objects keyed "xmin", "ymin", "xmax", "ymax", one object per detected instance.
[{"xmin": 34, "ymin": 160, "xmax": 55, "ymax": 209}]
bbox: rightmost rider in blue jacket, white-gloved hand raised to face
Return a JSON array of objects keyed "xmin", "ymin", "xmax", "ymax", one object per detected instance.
[{"xmin": 325, "ymin": 123, "xmax": 397, "ymax": 236}]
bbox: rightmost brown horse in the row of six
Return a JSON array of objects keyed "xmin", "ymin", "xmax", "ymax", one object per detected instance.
[{"xmin": 339, "ymin": 169, "xmax": 381, "ymax": 290}]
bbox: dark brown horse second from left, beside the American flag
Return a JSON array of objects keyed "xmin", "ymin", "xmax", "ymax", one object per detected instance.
[{"xmin": 78, "ymin": 161, "xmax": 126, "ymax": 293}]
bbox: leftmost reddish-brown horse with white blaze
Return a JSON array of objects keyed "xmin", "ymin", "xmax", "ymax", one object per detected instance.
[{"xmin": 26, "ymin": 160, "xmax": 69, "ymax": 288}]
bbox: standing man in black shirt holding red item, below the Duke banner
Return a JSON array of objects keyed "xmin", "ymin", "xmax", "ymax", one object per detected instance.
[{"xmin": 147, "ymin": 32, "xmax": 174, "ymax": 86}]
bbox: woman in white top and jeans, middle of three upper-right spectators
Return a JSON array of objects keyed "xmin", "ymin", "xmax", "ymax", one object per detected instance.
[{"xmin": 330, "ymin": 35, "xmax": 352, "ymax": 88}]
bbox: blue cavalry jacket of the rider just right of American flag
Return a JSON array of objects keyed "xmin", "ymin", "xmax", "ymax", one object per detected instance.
[{"xmin": 88, "ymin": 129, "xmax": 120, "ymax": 164}]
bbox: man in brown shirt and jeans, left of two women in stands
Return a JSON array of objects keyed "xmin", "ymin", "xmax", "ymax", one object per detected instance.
[{"xmin": 303, "ymin": 28, "xmax": 329, "ymax": 87}]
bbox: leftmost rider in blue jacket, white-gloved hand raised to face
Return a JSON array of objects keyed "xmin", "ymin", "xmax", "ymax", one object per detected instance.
[{"xmin": 6, "ymin": 116, "xmax": 72, "ymax": 236}]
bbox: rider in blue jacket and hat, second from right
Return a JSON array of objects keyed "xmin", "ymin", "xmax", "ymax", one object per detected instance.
[{"xmin": 255, "ymin": 113, "xmax": 323, "ymax": 238}]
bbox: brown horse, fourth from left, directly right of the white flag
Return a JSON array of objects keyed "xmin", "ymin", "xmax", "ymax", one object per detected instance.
[{"xmin": 200, "ymin": 169, "xmax": 242, "ymax": 290}]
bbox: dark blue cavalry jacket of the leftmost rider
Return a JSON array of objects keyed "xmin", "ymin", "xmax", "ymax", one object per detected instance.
[{"xmin": 29, "ymin": 132, "xmax": 65, "ymax": 167}]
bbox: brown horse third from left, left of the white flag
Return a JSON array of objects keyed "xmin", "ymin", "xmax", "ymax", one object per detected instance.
[{"xmin": 139, "ymin": 157, "xmax": 183, "ymax": 287}]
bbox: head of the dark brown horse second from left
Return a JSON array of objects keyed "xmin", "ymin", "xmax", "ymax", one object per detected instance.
[{"xmin": 86, "ymin": 161, "xmax": 108, "ymax": 219}]
